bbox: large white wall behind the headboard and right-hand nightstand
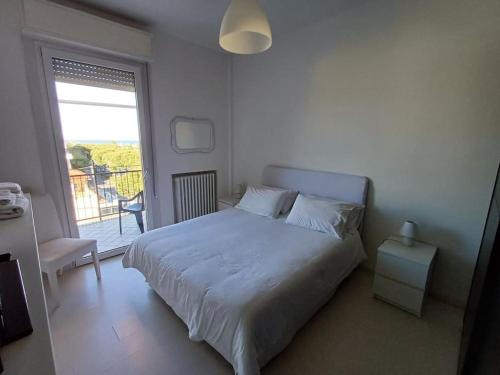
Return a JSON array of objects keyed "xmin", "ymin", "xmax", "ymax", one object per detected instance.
[{"xmin": 233, "ymin": 0, "xmax": 500, "ymax": 304}]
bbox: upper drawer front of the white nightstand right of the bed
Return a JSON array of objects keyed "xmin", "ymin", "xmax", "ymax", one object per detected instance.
[{"xmin": 376, "ymin": 252, "xmax": 428, "ymax": 290}]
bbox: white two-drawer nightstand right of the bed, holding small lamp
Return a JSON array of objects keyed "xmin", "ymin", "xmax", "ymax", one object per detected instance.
[{"xmin": 373, "ymin": 237, "xmax": 437, "ymax": 317}]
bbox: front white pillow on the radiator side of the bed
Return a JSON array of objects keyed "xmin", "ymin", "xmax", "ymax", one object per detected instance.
[{"xmin": 236, "ymin": 186, "xmax": 286, "ymax": 217}]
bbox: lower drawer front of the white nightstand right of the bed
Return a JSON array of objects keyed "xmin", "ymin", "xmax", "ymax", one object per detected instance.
[{"xmin": 373, "ymin": 274, "xmax": 425, "ymax": 316}]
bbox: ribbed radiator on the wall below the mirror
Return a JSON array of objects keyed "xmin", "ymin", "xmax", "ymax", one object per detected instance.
[{"xmin": 172, "ymin": 171, "xmax": 217, "ymax": 223}]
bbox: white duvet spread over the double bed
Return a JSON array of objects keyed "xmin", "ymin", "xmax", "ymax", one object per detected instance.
[{"xmin": 123, "ymin": 209, "xmax": 366, "ymax": 375}]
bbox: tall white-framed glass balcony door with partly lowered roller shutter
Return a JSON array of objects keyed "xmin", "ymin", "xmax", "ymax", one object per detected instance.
[{"xmin": 42, "ymin": 48, "xmax": 154, "ymax": 258}]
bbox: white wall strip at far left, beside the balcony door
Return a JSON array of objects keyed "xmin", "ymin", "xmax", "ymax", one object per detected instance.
[{"xmin": 0, "ymin": 0, "xmax": 43, "ymax": 191}]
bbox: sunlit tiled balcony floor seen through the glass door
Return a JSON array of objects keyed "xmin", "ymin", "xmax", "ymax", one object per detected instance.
[{"xmin": 78, "ymin": 212, "xmax": 146, "ymax": 253}]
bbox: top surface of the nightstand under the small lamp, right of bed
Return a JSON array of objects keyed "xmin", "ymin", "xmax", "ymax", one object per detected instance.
[{"xmin": 378, "ymin": 237, "xmax": 437, "ymax": 266}]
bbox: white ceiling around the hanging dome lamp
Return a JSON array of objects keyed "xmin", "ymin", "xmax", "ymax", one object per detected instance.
[{"xmin": 58, "ymin": 0, "xmax": 373, "ymax": 49}]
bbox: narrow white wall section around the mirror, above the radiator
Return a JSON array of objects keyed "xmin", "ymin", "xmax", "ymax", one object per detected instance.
[{"xmin": 147, "ymin": 32, "xmax": 228, "ymax": 225}]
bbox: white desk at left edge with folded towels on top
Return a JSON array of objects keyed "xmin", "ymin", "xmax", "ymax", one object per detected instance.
[{"xmin": 0, "ymin": 195, "xmax": 56, "ymax": 375}]
